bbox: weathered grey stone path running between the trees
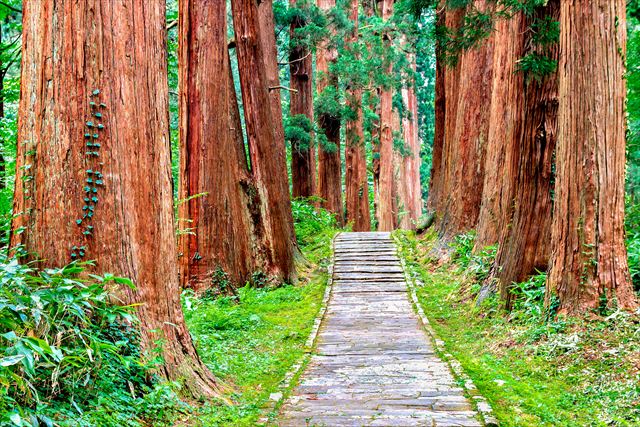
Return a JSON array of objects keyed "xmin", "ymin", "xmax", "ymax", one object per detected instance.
[{"xmin": 278, "ymin": 233, "xmax": 481, "ymax": 427}]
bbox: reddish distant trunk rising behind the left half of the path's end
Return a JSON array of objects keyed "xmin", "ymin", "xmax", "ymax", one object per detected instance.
[{"xmin": 344, "ymin": 0, "xmax": 371, "ymax": 231}]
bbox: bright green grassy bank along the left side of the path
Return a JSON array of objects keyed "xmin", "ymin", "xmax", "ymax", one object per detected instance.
[{"xmin": 178, "ymin": 200, "xmax": 338, "ymax": 427}]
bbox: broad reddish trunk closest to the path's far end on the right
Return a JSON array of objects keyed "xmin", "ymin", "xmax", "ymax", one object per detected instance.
[{"xmin": 437, "ymin": 0, "xmax": 493, "ymax": 241}]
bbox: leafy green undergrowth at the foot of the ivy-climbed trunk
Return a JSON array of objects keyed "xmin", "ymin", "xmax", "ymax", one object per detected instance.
[{"xmin": 0, "ymin": 258, "xmax": 188, "ymax": 426}]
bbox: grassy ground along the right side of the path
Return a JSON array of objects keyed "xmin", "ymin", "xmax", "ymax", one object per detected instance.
[{"xmin": 399, "ymin": 233, "xmax": 640, "ymax": 426}]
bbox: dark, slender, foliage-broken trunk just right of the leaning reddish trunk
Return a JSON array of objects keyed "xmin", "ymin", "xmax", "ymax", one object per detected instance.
[{"xmin": 289, "ymin": 0, "xmax": 316, "ymax": 197}]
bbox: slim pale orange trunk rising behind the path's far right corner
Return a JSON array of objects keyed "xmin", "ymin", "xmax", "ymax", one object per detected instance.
[{"xmin": 376, "ymin": 0, "xmax": 396, "ymax": 231}]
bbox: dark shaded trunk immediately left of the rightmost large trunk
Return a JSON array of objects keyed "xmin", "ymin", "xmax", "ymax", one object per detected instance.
[{"xmin": 479, "ymin": 0, "xmax": 560, "ymax": 309}]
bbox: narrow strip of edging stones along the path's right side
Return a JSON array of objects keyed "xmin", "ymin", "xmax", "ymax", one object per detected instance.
[{"xmin": 391, "ymin": 233, "xmax": 499, "ymax": 427}]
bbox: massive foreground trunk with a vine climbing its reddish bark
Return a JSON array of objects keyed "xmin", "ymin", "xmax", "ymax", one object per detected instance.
[{"xmin": 11, "ymin": 0, "xmax": 217, "ymax": 396}]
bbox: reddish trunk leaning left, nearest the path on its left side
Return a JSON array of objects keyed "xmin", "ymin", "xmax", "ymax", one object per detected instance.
[{"xmin": 231, "ymin": 0, "xmax": 296, "ymax": 282}]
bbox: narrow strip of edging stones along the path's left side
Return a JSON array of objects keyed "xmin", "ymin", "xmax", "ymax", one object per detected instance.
[{"xmin": 257, "ymin": 231, "xmax": 342, "ymax": 426}]
